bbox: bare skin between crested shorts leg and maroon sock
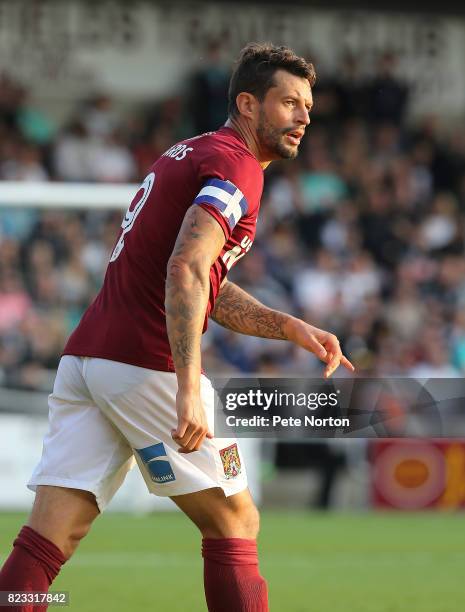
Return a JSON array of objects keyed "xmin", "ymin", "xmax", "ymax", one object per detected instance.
[{"xmin": 171, "ymin": 488, "xmax": 259, "ymax": 538}]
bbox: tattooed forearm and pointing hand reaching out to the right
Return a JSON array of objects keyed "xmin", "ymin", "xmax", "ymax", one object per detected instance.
[{"xmin": 211, "ymin": 281, "xmax": 354, "ymax": 378}]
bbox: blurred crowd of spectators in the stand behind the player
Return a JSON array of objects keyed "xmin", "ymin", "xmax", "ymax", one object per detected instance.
[{"xmin": 0, "ymin": 50, "xmax": 465, "ymax": 389}]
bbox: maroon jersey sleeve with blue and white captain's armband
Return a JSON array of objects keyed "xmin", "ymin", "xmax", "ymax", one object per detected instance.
[{"xmin": 194, "ymin": 152, "xmax": 263, "ymax": 240}]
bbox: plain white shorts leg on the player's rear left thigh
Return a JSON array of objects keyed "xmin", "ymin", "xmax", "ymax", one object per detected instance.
[{"xmin": 28, "ymin": 356, "xmax": 134, "ymax": 510}]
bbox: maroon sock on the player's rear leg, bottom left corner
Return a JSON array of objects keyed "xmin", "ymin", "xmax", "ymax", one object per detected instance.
[{"xmin": 0, "ymin": 526, "xmax": 66, "ymax": 612}]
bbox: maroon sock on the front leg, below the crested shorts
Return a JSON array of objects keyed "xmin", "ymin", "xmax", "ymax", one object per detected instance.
[{"xmin": 202, "ymin": 538, "xmax": 268, "ymax": 612}]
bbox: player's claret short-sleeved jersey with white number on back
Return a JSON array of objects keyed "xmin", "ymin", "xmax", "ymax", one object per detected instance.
[{"xmin": 63, "ymin": 127, "xmax": 263, "ymax": 371}]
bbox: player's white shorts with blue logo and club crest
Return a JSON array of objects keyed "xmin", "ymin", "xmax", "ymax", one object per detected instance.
[{"xmin": 27, "ymin": 355, "xmax": 247, "ymax": 511}]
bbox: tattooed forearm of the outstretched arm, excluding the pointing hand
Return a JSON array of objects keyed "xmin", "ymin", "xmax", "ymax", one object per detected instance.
[{"xmin": 211, "ymin": 281, "xmax": 290, "ymax": 340}]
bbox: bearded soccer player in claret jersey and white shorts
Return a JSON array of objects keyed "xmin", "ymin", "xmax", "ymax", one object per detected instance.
[{"xmin": 0, "ymin": 44, "xmax": 353, "ymax": 612}]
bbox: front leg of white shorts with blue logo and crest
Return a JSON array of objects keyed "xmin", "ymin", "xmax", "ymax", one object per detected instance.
[{"xmin": 86, "ymin": 359, "xmax": 247, "ymax": 497}]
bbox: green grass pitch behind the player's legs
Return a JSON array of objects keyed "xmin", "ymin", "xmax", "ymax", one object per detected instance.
[{"xmin": 0, "ymin": 512, "xmax": 465, "ymax": 612}]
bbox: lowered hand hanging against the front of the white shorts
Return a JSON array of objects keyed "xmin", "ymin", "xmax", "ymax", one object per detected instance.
[{"xmin": 171, "ymin": 391, "xmax": 213, "ymax": 453}]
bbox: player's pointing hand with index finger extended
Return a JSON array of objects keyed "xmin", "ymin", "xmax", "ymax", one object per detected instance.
[{"xmin": 288, "ymin": 318, "xmax": 355, "ymax": 378}]
